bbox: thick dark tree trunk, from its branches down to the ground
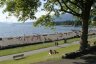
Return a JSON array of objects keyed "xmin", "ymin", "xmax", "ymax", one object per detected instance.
[{"xmin": 80, "ymin": 8, "xmax": 90, "ymax": 50}]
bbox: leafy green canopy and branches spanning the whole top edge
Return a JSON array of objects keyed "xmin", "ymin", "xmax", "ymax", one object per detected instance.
[{"xmin": 0, "ymin": 0, "xmax": 96, "ymax": 20}]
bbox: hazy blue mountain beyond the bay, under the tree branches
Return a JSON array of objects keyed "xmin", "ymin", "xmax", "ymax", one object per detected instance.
[{"xmin": 54, "ymin": 13, "xmax": 76, "ymax": 22}]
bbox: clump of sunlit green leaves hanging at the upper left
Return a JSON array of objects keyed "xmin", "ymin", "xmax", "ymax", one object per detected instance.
[{"xmin": 1, "ymin": 0, "xmax": 41, "ymax": 21}]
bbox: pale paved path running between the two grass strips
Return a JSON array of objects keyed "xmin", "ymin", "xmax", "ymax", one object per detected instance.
[{"xmin": 0, "ymin": 41, "xmax": 79, "ymax": 61}]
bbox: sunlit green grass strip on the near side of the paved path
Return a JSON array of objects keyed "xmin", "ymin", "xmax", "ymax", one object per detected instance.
[{"xmin": 0, "ymin": 44, "xmax": 79, "ymax": 64}]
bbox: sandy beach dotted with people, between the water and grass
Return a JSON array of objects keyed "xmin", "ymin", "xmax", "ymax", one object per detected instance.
[{"xmin": 0, "ymin": 30, "xmax": 96, "ymax": 49}]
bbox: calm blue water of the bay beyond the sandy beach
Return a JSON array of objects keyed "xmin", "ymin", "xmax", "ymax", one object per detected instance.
[{"xmin": 0, "ymin": 23, "xmax": 80, "ymax": 37}]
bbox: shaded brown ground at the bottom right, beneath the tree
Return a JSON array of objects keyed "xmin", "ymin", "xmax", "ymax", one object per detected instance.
[{"xmin": 33, "ymin": 53, "xmax": 96, "ymax": 64}]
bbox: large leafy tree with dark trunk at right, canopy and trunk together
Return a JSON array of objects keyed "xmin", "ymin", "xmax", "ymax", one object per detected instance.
[{"xmin": 1, "ymin": 0, "xmax": 96, "ymax": 50}]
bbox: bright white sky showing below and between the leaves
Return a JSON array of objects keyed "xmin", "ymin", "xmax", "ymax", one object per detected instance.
[{"xmin": 0, "ymin": 8, "xmax": 47, "ymax": 23}]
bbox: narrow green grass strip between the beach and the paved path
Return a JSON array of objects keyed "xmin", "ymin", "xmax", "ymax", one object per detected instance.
[{"xmin": 0, "ymin": 38, "xmax": 79, "ymax": 56}]
